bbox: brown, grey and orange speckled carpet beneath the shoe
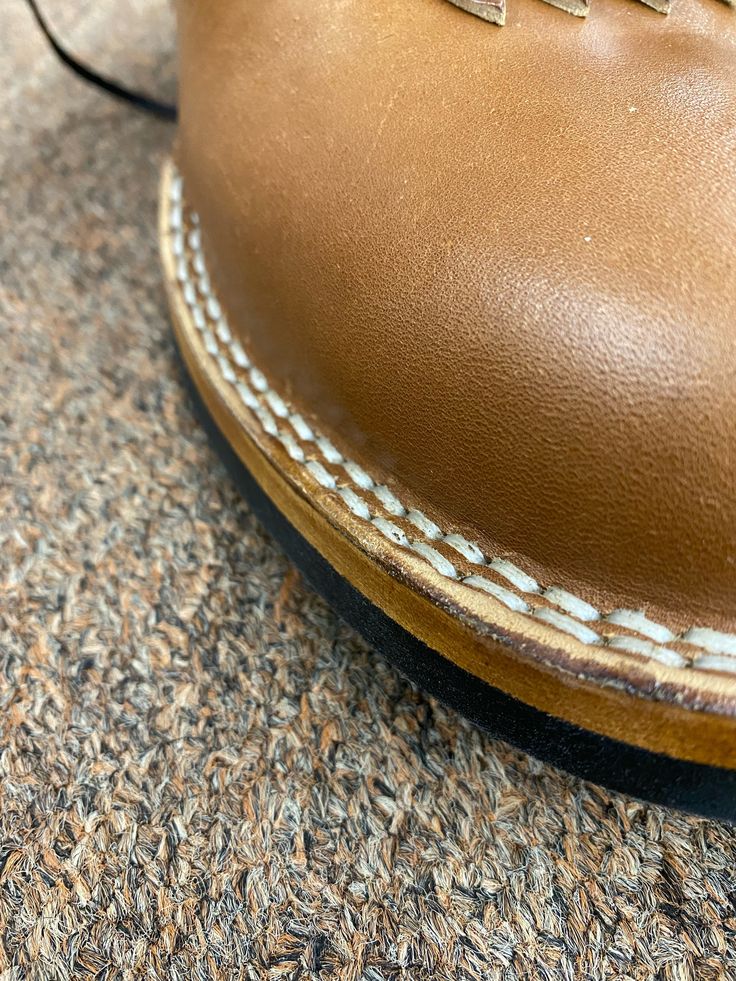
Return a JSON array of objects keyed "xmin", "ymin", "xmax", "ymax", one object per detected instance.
[{"xmin": 0, "ymin": 0, "xmax": 736, "ymax": 981}]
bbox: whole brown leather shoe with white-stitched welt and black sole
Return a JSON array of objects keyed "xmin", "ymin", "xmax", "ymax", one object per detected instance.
[{"xmin": 161, "ymin": 0, "xmax": 736, "ymax": 814}]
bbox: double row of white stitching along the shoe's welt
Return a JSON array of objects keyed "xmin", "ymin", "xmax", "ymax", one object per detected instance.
[{"xmin": 169, "ymin": 170, "xmax": 736, "ymax": 673}]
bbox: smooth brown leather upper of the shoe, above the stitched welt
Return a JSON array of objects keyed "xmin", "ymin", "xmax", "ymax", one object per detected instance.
[{"xmin": 178, "ymin": 0, "xmax": 736, "ymax": 630}]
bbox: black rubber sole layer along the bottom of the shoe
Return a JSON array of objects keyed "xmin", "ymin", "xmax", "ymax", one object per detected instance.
[{"xmin": 182, "ymin": 364, "xmax": 736, "ymax": 822}]
